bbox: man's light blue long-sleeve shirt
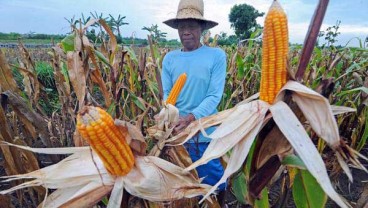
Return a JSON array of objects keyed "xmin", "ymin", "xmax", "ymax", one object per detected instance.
[{"xmin": 161, "ymin": 46, "xmax": 226, "ymax": 142}]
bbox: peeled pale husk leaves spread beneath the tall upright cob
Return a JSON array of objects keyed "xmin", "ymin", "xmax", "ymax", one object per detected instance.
[{"xmin": 175, "ymin": 81, "xmax": 366, "ymax": 207}]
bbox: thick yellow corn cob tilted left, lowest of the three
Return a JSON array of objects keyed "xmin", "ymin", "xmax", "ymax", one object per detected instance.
[{"xmin": 77, "ymin": 106, "xmax": 134, "ymax": 176}]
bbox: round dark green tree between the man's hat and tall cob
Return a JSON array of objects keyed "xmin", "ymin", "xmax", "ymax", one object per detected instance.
[{"xmin": 229, "ymin": 4, "xmax": 264, "ymax": 39}]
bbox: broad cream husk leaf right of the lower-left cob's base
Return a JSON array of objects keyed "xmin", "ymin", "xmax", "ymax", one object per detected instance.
[{"xmin": 124, "ymin": 156, "xmax": 210, "ymax": 201}]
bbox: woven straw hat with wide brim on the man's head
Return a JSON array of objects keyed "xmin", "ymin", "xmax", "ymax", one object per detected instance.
[{"xmin": 164, "ymin": 0, "xmax": 218, "ymax": 30}]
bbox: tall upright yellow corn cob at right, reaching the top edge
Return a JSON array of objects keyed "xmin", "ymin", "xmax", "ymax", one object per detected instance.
[{"xmin": 260, "ymin": 0, "xmax": 289, "ymax": 103}]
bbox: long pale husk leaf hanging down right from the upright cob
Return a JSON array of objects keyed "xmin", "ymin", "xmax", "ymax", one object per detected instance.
[{"xmin": 270, "ymin": 101, "xmax": 350, "ymax": 207}]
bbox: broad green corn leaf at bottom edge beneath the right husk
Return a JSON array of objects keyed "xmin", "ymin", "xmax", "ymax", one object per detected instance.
[{"xmin": 293, "ymin": 170, "xmax": 327, "ymax": 208}]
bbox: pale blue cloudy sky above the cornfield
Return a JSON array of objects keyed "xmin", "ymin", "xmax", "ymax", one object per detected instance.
[{"xmin": 0, "ymin": 0, "xmax": 368, "ymax": 45}]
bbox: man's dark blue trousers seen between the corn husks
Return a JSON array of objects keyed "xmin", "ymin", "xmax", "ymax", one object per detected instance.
[{"xmin": 184, "ymin": 142, "xmax": 226, "ymax": 191}]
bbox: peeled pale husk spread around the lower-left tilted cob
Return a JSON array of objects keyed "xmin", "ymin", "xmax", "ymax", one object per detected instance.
[{"xmin": 0, "ymin": 118, "xmax": 210, "ymax": 207}]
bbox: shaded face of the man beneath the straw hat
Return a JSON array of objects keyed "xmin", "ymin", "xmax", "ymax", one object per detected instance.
[{"xmin": 178, "ymin": 19, "xmax": 202, "ymax": 51}]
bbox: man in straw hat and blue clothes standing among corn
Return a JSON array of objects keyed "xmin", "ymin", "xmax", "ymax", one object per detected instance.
[{"xmin": 162, "ymin": 0, "xmax": 226, "ymax": 201}]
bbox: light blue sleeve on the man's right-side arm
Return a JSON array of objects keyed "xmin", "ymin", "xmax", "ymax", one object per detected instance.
[{"xmin": 191, "ymin": 51, "xmax": 226, "ymax": 119}]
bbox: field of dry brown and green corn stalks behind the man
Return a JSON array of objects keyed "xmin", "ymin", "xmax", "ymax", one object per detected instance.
[{"xmin": 0, "ymin": 2, "xmax": 368, "ymax": 207}]
